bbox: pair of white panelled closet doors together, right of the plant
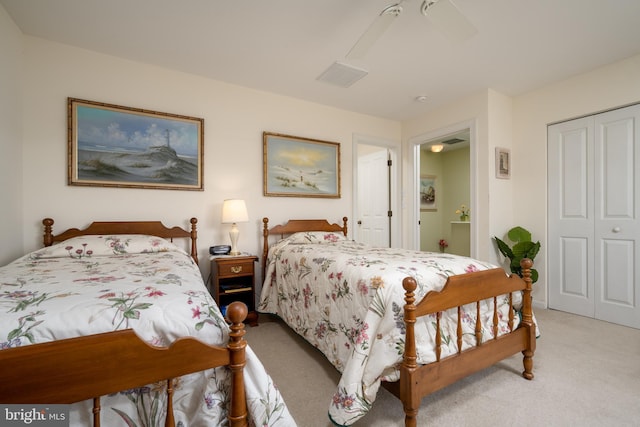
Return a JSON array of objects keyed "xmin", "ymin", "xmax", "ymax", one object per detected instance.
[{"xmin": 548, "ymin": 106, "xmax": 640, "ymax": 328}]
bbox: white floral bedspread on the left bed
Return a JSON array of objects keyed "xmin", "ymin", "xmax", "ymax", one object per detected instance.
[{"xmin": 0, "ymin": 235, "xmax": 295, "ymax": 427}]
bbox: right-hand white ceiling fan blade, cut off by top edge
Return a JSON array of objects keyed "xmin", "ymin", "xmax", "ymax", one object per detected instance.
[{"xmin": 421, "ymin": 0, "xmax": 478, "ymax": 41}]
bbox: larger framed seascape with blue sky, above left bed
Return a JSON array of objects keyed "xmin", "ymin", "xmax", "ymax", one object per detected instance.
[{"xmin": 67, "ymin": 98, "xmax": 204, "ymax": 190}]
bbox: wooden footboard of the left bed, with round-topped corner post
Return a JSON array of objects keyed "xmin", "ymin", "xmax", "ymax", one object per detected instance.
[{"xmin": 0, "ymin": 302, "xmax": 247, "ymax": 426}]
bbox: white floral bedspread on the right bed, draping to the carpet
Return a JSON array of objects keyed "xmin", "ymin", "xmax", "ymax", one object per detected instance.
[{"xmin": 259, "ymin": 232, "xmax": 521, "ymax": 425}]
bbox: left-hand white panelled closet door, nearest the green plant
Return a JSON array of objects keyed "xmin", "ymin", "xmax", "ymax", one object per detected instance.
[{"xmin": 547, "ymin": 117, "xmax": 595, "ymax": 317}]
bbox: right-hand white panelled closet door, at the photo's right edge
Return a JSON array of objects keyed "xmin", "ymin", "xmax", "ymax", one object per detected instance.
[{"xmin": 594, "ymin": 106, "xmax": 640, "ymax": 328}]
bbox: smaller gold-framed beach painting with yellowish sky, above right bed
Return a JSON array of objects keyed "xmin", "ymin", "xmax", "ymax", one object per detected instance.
[{"xmin": 262, "ymin": 132, "xmax": 340, "ymax": 198}]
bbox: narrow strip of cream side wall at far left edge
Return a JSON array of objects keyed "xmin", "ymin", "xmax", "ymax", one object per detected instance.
[{"xmin": 0, "ymin": 7, "xmax": 24, "ymax": 265}]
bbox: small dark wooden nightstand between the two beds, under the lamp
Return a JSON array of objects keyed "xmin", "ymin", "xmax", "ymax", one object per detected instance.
[{"xmin": 209, "ymin": 255, "xmax": 258, "ymax": 326}]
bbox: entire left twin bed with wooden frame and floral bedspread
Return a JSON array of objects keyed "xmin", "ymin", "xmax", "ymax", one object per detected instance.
[{"xmin": 0, "ymin": 218, "xmax": 293, "ymax": 426}]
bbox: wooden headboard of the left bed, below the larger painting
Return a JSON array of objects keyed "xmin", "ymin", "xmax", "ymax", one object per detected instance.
[{"xmin": 42, "ymin": 218, "xmax": 198, "ymax": 264}]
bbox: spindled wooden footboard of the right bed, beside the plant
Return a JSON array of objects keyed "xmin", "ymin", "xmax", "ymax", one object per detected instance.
[{"xmin": 384, "ymin": 259, "xmax": 536, "ymax": 427}]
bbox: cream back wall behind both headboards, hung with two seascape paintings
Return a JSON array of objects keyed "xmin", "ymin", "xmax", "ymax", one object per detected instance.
[{"xmin": 16, "ymin": 37, "xmax": 400, "ymax": 284}]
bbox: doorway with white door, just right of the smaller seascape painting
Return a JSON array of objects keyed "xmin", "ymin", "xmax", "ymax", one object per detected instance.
[{"xmin": 351, "ymin": 135, "xmax": 400, "ymax": 247}]
